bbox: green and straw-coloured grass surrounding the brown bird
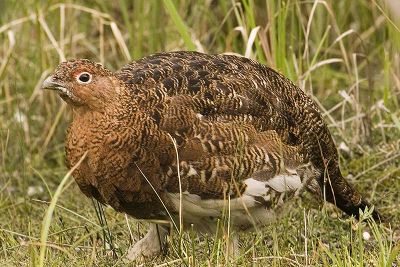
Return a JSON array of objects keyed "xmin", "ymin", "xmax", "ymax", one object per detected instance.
[{"xmin": 0, "ymin": 0, "xmax": 400, "ymax": 266}]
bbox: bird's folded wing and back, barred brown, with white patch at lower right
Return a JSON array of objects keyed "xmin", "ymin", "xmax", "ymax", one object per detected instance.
[{"xmin": 117, "ymin": 52, "xmax": 310, "ymax": 201}]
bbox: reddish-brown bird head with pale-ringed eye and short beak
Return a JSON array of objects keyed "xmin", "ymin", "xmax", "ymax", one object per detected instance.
[{"xmin": 42, "ymin": 59, "xmax": 120, "ymax": 110}]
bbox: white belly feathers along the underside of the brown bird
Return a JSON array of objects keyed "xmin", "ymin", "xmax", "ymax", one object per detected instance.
[{"xmin": 168, "ymin": 173, "xmax": 307, "ymax": 233}]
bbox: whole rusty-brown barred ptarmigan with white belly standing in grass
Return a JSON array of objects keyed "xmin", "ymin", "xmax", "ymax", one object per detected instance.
[{"xmin": 43, "ymin": 52, "xmax": 379, "ymax": 259}]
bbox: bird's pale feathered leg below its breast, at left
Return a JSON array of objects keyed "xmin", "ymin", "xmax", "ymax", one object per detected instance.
[{"xmin": 126, "ymin": 223, "xmax": 169, "ymax": 261}]
